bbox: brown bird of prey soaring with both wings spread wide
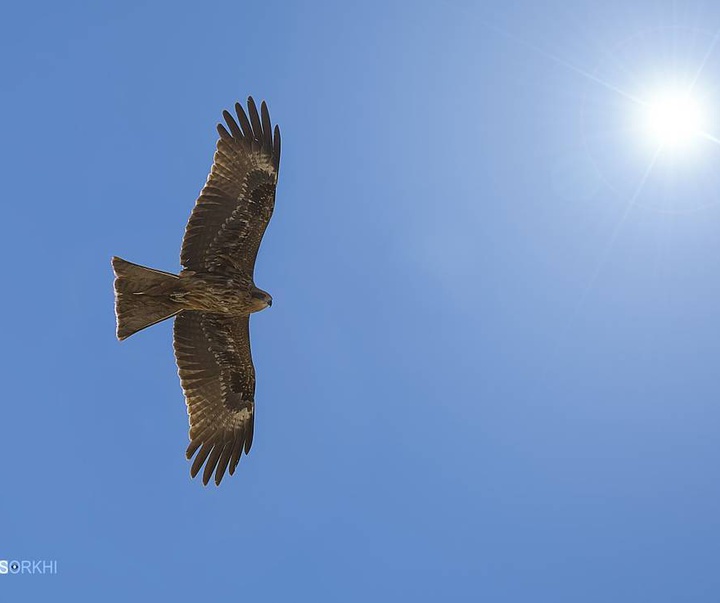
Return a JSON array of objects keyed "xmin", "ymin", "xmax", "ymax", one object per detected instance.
[{"xmin": 112, "ymin": 97, "xmax": 280, "ymax": 485}]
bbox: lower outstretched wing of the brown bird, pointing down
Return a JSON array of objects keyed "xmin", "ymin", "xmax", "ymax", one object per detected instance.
[{"xmin": 174, "ymin": 310, "xmax": 255, "ymax": 485}]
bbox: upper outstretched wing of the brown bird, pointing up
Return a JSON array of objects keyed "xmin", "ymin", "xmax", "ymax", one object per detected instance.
[{"xmin": 180, "ymin": 97, "xmax": 280, "ymax": 278}]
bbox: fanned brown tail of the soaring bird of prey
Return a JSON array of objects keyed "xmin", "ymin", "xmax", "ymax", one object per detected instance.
[{"xmin": 112, "ymin": 257, "xmax": 182, "ymax": 340}]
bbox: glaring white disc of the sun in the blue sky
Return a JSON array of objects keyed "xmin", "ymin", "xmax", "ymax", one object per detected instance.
[{"xmin": 645, "ymin": 90, "xmax": 705, "ymax": 149}]
